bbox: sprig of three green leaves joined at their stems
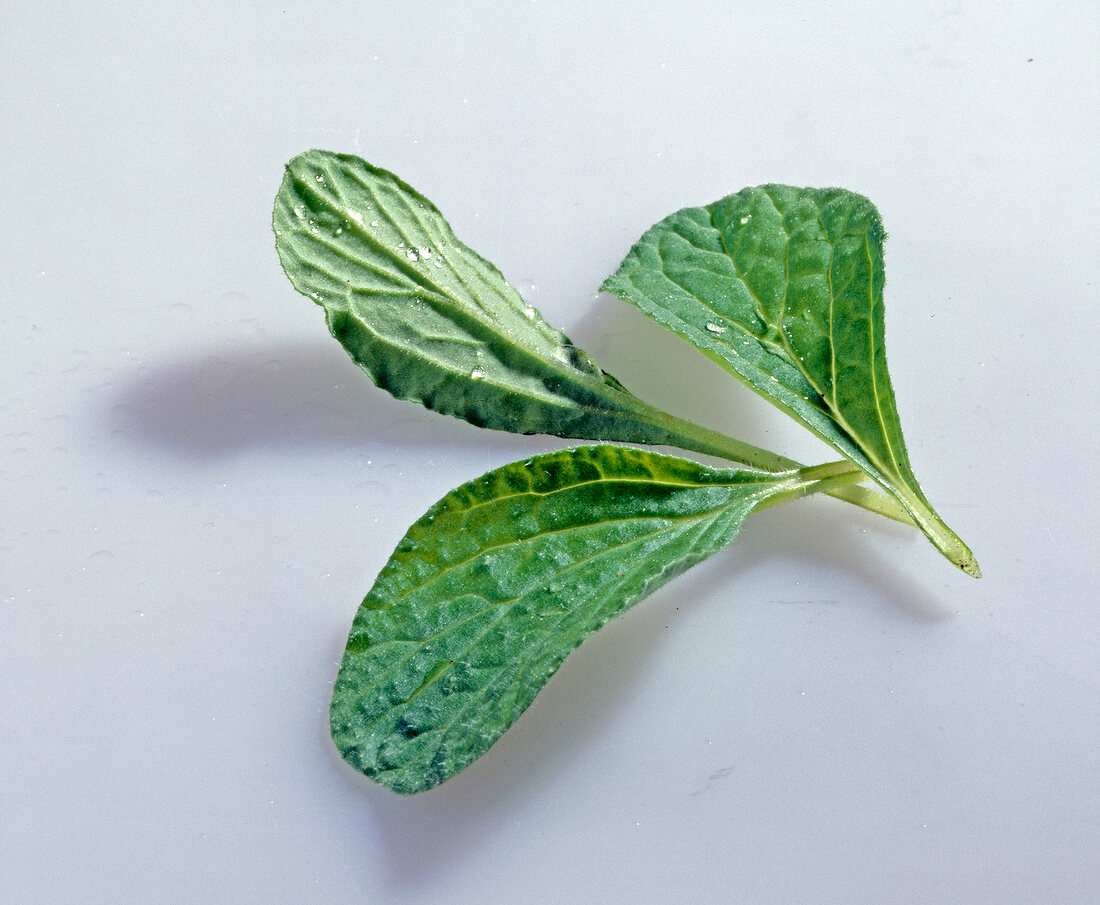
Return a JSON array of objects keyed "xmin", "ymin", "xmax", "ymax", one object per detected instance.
[{"xmin": 274, "ymin": 151, "xmax": 980, "ymax": 793}]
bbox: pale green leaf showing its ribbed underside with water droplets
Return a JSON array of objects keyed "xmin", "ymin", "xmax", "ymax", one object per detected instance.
[{"xmin": 274, "ymin": 151, "xmax": 905, "ymax": 518}]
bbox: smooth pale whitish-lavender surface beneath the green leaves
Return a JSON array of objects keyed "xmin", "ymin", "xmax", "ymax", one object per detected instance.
[{"xmin": 0, "ymin": 2, "xmax": 1100, "ymax": 905}]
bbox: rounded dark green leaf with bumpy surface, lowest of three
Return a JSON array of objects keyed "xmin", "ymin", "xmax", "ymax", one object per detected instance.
[{"xmin": 331, "ymin": 445, "xmax": 818, "ymax": 793}]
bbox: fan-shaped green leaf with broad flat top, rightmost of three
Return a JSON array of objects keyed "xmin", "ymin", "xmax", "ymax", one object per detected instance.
[{"xmin": 603, "ymin": 185, "xmax": 980, "ymax": 576}]
